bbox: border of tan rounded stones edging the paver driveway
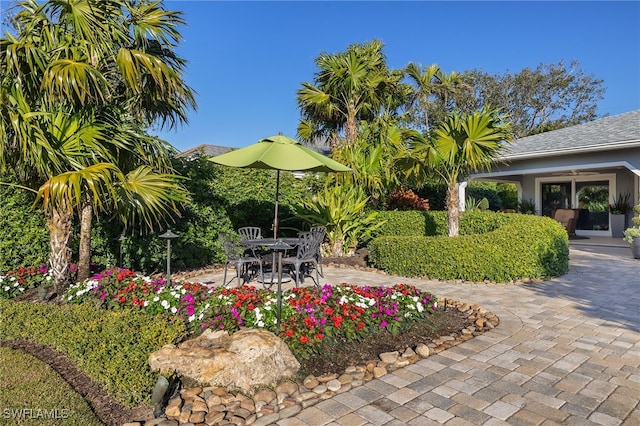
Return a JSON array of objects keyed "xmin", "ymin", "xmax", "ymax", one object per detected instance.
[{"xmin": 123, "ymin": 299, "xmax": 500, "ymax": 426}]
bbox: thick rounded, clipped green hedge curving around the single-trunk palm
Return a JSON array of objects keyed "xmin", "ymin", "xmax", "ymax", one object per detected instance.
[{"xmin": 369, "ymin": 212, "xmax": 569, "ymax": 282}]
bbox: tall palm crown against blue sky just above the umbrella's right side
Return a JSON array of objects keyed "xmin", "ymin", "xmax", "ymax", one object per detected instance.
[{"xmin": 298, "ymin": 40, "xmax": 407, "ymax": 150}]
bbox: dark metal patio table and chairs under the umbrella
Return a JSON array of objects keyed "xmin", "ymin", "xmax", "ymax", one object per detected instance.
[{"xmin": 218, "ymin": 226, "xmax": 326, "ymax": 288}]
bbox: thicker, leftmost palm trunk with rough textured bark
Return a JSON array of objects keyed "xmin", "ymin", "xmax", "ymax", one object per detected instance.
[{"xmin": 48, "ymin": 206, "xmax": 71, "ymax": 296}]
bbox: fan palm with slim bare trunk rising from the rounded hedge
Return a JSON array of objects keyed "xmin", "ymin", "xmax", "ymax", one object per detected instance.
[{"xmin": 411, "ymin": 109, "xmax": 512, "ymax": 237}]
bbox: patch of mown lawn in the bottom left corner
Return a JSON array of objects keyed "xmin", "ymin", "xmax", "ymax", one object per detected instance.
[{"xmin": 0, "ymin": 347, "xmax": 102, "ymax": 426}]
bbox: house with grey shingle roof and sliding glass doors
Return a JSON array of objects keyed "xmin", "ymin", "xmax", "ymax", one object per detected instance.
[{"xmin": 461, "ymin": 110, "xmax": 640, "ymax": 237}]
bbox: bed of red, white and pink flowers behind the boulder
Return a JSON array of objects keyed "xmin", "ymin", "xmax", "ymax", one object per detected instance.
[{"xmin": 64, "ymin": 268, "xmax": 437, "ymax": 359}]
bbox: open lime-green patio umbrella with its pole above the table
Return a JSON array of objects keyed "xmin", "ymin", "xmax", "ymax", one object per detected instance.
[{"xmin": 209, "ymin": 135, "xmax": 351, "ymax": 238}]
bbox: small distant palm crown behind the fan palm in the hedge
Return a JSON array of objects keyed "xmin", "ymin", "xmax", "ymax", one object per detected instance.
[{"xmin": 404, "ymin": 62, "xmax": 473, "ymax": 132}]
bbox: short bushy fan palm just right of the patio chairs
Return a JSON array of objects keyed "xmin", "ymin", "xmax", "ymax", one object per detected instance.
[{"xmin": 296, "ymin": 184, "xmax": 382, "ymax": 256}]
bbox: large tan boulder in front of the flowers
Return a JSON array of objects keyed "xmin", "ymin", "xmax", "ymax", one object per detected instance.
[{"xmin": 149, "ymin": 328, "xmax": 300, "ymax": 393}]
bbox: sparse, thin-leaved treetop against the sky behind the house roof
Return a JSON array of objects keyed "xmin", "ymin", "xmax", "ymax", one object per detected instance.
[{"xmin": 462, "ymin": 61, "xmax": 605, "ymax": 138}]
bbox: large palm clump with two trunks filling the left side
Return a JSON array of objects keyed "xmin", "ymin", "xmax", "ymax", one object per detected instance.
[{"xmin": 0, "ymin": 0, "xmax": 195, "ymax": 293}]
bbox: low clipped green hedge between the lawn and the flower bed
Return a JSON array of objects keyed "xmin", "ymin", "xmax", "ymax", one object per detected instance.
[{"xmin": 0, "ymin": 299, "xmax": 185, "ymax": 407}]
